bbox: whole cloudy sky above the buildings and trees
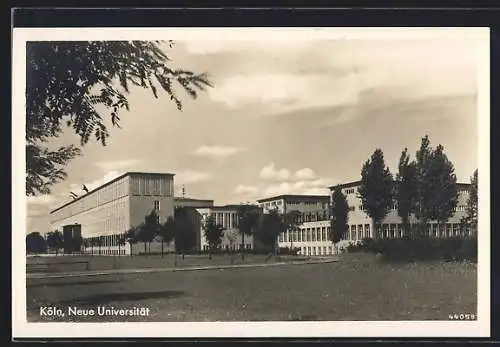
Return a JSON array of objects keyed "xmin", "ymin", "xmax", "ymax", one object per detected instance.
[{"xmin": 27, "ymin": 31, "xmax": 478, "ymax": 232}]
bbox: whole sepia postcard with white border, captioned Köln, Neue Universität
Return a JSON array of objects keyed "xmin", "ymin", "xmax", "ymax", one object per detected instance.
[{"xmin": 12, "ymin": 27, "xmax": 490, "ymax": 337}]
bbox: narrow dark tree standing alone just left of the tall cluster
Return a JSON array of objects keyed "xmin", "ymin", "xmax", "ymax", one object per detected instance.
[{"xmin": 328, "ymin": 186, "xmax": 349, "ymax": 253}]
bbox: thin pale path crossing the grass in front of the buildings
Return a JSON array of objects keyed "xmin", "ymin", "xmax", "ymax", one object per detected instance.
[{"xmin": 26, "ymin": 257, "xmax": 339, "ymax": 279}]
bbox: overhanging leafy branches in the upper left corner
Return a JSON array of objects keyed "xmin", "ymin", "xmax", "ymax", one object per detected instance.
[{"xmin": 26, "ymin": 41, "xmax": 212, "ymax": 195}]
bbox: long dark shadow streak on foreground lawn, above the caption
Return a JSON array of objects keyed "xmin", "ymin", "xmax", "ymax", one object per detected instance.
[{"xmin": 58, "ymin": 290, "xmax": 185, "ymax": 306}]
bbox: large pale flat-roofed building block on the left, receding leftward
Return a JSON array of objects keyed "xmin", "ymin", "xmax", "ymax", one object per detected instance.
[{"xmin": 50, "ymin": 172, "xmax": 174, "ymax": 255}]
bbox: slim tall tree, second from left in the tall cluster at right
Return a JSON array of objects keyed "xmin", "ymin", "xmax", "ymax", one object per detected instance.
[{"xmin": 395, "ymin": 148, "xmax": 419, "ymax": 235}]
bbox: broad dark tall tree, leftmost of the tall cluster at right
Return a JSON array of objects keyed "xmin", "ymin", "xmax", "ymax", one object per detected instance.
[{"xmin": 358, "ymin": 149, "xmax": 394, "ymax": 238}]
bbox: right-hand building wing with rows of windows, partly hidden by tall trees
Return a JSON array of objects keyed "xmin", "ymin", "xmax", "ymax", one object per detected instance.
[{"xmin": 258, "ymin": 181, "xmax": 473, "ymax": 256}]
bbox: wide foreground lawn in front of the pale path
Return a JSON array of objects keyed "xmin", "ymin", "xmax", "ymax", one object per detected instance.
[{"xmin": 27, "ymin": 254, "xmax": 477, "ymax": 322}]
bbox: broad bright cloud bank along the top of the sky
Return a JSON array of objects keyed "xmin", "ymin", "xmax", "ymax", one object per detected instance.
[{"xmin": 203, "ymin": 36, "xmax": 478, "ymax": 118}]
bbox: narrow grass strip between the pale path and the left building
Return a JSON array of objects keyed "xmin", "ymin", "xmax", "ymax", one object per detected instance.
[{"xmin": 26, "ymin": 254, "xmax": 307, "ymax": 273}]
